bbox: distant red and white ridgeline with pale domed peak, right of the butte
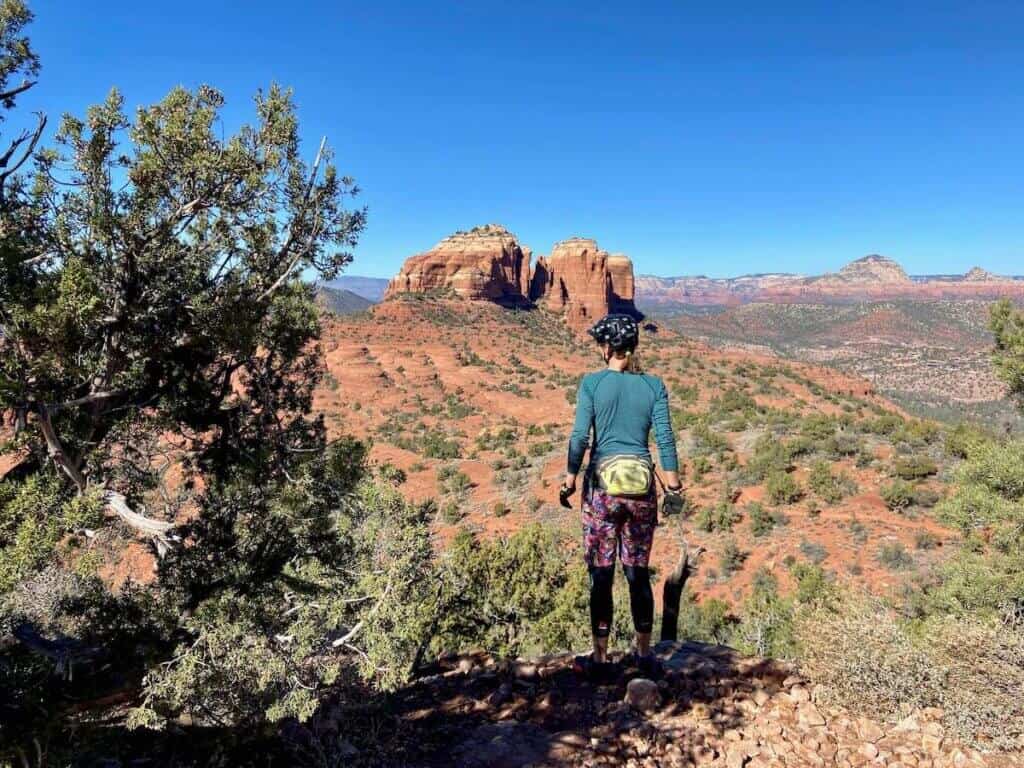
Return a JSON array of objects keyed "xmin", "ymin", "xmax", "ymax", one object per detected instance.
[{"xmin": 636, "ymin": 254, "xmax": 1024, "ymax": 307}]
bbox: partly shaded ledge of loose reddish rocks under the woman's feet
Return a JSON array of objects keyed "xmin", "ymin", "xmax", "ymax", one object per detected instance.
[{"xmin": 337, "ymin": 642, "xmax": 1024, "ymax": 768}]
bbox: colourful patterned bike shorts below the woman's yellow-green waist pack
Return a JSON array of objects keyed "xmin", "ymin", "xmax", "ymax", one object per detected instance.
[{"xmin": 583, "ymin": 488, "xmax": 657, "ymax": 567}]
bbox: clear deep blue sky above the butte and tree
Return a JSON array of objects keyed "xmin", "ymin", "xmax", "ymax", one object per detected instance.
[{"xmin": 22, "ymin": 0, "xmax": 1024, "ymax": 276}]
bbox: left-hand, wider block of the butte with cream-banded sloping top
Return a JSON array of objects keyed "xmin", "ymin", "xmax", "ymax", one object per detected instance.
[{"xmin": 384, "ymin": 224, "xmax": 530, "ymax": 303}]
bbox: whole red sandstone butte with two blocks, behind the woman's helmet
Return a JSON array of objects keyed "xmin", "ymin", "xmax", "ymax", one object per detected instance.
[{"xmin": 384, "ymin": 224, "xmax": 636, "ymax": 329}]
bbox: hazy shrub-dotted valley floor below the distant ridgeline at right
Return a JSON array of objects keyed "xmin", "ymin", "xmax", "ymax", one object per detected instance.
[{"xmin": 654, "ymin": 300, "xmax": 1024, "ymax": 430}]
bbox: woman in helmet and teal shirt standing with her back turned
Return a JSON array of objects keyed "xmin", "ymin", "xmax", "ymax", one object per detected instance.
[{"xmin": 559, "ymin": 314, "xmax": 682, "ymax": 679}]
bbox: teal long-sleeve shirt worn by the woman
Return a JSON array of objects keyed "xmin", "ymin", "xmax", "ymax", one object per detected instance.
[{"xmin": 568, "ymin": 369, "xmax": 679, "ymax": 474}]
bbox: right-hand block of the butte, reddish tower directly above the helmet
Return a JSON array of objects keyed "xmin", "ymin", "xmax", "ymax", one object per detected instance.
[{"xmin": 529, "ymin": 238, "xmax": 635, "ymax": 328}]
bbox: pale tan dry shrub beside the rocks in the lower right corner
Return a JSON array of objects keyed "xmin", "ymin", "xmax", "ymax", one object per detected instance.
[{"xmin": 796, "ymin": 594, "xmax": 1024, "ymax": 751}]
